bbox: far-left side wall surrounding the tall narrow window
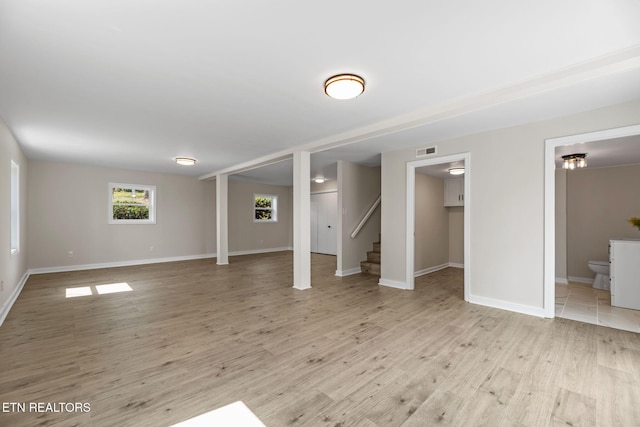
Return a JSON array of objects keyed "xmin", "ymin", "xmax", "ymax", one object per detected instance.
[{"xmin": 0, "ymin": 119, "xmax": 29, "ymax": 323}]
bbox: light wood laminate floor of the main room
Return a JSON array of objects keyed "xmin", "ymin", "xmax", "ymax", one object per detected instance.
[{"xmin": 0, "ymin": 252, "xmax": 640, "ymax": 427}]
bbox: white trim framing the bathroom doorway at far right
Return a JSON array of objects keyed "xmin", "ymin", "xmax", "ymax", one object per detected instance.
[{"xmin": 544, "ymin": 124, "xmax": 640, "ymax": 318}]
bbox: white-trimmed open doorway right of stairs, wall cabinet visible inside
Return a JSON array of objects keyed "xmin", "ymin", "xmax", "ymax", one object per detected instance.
[{"xmin": 406, "ymin": 153, "xmax": 471, "ymax": 301}]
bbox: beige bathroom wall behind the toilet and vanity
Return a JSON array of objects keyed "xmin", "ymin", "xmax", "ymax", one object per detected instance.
[{"xmin": 567, "ymin": 165, "xmax": 640, "ymax": 281}]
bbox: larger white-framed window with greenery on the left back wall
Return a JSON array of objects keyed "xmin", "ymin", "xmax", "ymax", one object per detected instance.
[{"xmin": 109, "ymin": 183, "xmax": 156, "ymax": 224}]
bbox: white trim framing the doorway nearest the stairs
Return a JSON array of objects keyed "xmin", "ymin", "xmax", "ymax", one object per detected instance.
[{"xmin": 405, "ymin": 152, "xmax": 472, "ymax": 301}]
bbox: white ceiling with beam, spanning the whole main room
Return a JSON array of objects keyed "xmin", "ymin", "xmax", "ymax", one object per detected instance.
[{"xmin": 0, "ymin": 0, "xmax": 640, "ymax": 183}]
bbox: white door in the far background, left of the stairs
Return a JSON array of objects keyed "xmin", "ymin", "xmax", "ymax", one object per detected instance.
[{"xmin": 311, "ymin": 192, "xmax": 338, "ymax": 255}]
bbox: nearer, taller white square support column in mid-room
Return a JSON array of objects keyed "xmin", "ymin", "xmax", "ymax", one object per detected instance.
[{"xmin": 293, "ymin": 151, "xmax": 311, "ymax": 290}]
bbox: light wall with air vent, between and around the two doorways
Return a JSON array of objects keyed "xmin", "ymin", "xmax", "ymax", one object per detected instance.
[{"xmin": 381, "ymin": 101, "xmax": 640, "ymax": 314}]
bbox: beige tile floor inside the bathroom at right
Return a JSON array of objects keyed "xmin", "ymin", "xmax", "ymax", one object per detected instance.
[{"xmin": 556, "ymin": 282, "xmax": 640, "ymax": 332}]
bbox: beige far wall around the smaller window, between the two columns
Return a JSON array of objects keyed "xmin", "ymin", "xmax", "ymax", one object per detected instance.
[{"xmin": 229, "ymin": 180, "xmax": 293, "ymax": 253}]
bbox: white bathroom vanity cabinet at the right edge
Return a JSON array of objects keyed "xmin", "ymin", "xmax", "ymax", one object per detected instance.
[{"xmin": 609, "ymin": 239, "xmax": 640, "ymax": 310}]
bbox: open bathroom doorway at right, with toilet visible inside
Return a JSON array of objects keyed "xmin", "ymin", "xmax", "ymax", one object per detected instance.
[{"xmin": 545, "ymin": 126, "xmax": 640, "ymax": 332}]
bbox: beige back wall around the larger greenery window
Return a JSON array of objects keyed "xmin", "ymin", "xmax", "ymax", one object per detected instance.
[{"xmin": 28, "ymin": 161, "xmax": 216, "ymax": 269}]
